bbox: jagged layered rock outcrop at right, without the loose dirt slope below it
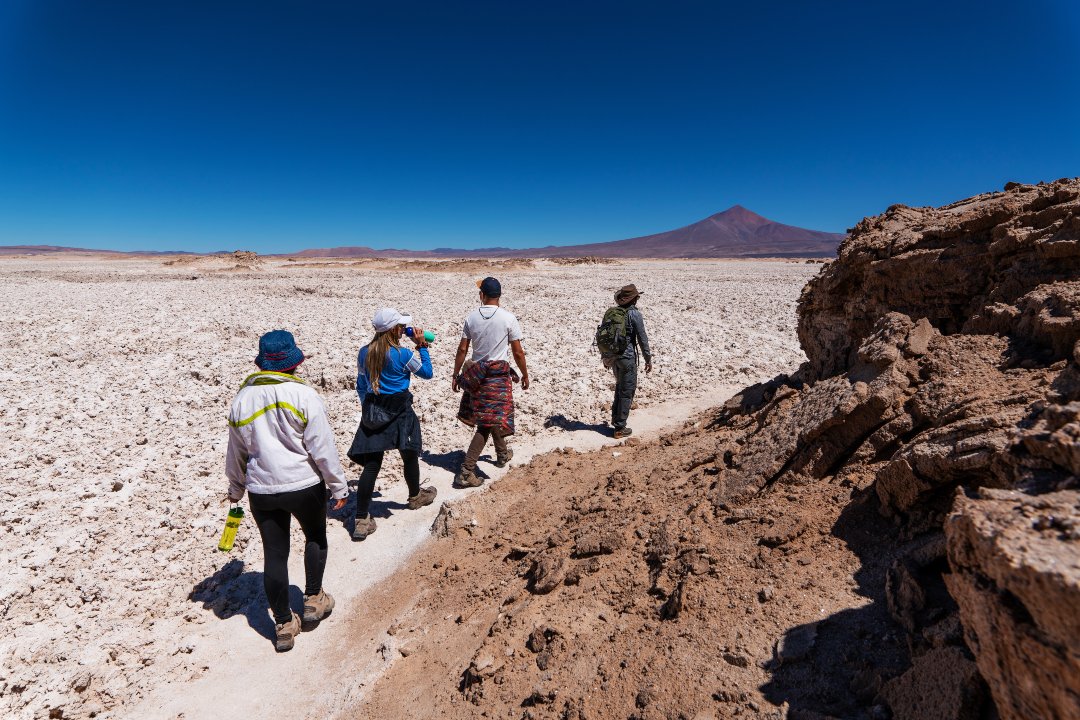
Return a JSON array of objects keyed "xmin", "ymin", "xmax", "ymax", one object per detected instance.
[{"xmin": 713, "ymin": 180, "xmax": 1080, "ymax": 718}]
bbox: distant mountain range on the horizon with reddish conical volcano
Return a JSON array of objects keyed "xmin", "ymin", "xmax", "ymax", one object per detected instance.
[{"xmin": 0, "ymin": 205, "xmax": 845, "ymax": 258}]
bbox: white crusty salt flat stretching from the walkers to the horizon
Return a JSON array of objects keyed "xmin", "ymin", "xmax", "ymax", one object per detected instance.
[{"xmin": 0, "ymin": 257, "xmax": 819, "ymax": 718}]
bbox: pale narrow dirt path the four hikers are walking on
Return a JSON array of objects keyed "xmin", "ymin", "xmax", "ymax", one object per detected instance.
[{"xmin": 125, "ymin": 385, "xmax": 739, "ymax": 718}]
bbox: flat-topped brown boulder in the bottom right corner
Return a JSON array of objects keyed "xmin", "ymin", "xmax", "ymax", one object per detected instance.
[{"xmin": 945, "ymin": 490, "xmax": 1080, "ymax": 720}]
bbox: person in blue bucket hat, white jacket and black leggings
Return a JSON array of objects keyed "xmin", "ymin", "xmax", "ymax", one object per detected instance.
[{"xmin": 225, "ymin": 330, "xmax": 349, "ymax": 652}]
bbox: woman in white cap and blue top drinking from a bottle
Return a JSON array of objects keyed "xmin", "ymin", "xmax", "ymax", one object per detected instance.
[{"xmin": 349, "ymin": 308, "xmax": 437, "ymax": 540}]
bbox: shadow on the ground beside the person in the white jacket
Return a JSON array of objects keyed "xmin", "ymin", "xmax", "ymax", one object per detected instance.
[{"xmin": 188, "ymin": 558, "xmax": 303, "ymax": 642}]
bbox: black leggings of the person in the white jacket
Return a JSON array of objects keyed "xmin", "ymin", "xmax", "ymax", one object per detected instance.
[{"xmin": 247, "ymin": 483, "xmax": 326, "ymax": 625}]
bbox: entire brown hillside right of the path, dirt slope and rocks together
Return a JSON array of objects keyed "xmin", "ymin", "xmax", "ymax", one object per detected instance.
[{"xmin": 339, "ymin": 179, "xmax": 1080, "ymax": 720}]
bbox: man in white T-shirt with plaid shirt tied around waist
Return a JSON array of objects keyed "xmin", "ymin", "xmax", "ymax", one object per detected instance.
[{"xmin": 450, "ymin": 277, "xmax": 529, "ymax": 488}]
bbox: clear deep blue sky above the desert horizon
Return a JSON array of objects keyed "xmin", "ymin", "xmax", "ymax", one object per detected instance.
[{"xmin": 0, "ymin": 0, "xmax": 1080, "ymax": 253}]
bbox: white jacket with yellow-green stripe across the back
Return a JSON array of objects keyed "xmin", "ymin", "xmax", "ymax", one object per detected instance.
[{"xmin": 225, "ymin": 372, "xmax": 349, "ymax": 502}]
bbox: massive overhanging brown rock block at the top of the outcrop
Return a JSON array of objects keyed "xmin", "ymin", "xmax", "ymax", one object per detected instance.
[{"xmin": 798, "ymin": 179, "xmax": 1080, "ymax": 377}]
